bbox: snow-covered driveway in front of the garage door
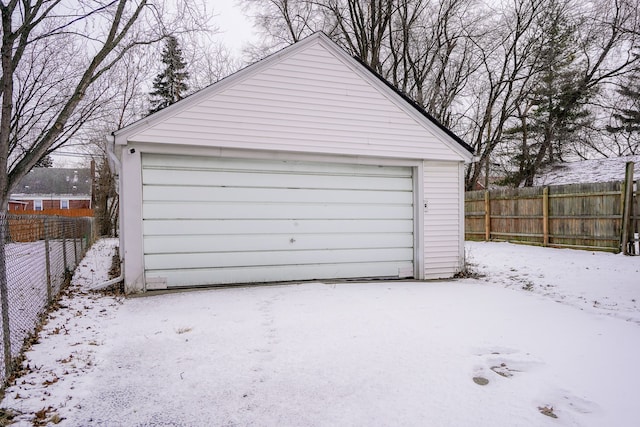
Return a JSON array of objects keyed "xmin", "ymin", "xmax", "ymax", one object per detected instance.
[{"xmin": 84, "ymin": 283, "xmax": 640, "ymax": 426}]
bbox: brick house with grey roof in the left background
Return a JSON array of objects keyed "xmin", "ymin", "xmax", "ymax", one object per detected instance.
[{"xmin": 9, "ymin": 168, "xmax": 93, "ymax": 212}]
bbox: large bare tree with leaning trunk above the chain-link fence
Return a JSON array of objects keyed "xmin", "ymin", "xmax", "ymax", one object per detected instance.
[{"xmin": 0, "ymin": 0, "xmax": 158, "ymax": 210}]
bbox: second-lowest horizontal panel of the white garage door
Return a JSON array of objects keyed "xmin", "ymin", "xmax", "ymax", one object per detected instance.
[{"xmin": 145, "ymin": 248, "xmax": 413, "ymax": 270}]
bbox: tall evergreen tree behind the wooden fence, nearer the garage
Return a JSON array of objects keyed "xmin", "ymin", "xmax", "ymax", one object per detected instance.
[{"xmin": 505, "ymin": 0, "xmax": 591, "ymax": 186}]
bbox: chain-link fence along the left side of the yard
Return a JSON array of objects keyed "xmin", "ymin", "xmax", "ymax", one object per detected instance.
[{"xmin": 0, "ymin": 214, "xmax": 96, "ymax": 383}]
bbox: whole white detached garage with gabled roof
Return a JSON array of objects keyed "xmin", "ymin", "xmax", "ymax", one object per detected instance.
[{"xmin": 114, "ymin": 33, "xmax": 471, "ymax": 292}]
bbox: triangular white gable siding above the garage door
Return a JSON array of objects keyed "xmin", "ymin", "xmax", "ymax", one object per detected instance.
[{"xmin": 128, "ymin": 38, "xmax": 463, "ymax": 160}]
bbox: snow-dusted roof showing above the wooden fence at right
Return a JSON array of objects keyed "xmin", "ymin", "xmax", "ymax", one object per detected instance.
[{"xmin": 533, "ymin": 155, "xmax": 640, "ymax": 186}]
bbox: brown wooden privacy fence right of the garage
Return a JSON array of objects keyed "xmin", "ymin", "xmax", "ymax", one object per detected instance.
[{"xmin": 465, "ymin": 180, "xmax": 640, "ymax": 253}]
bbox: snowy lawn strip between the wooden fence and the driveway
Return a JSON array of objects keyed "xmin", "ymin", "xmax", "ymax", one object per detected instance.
[{"xmin": 467, "ymin": 242, "xmax": 640, "ymax": 325}]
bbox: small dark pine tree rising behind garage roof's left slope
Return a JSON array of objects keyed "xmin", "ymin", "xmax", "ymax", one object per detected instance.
[{"xmin": 149, "ymin": 36, "xmax": 189, "ymax": 114}]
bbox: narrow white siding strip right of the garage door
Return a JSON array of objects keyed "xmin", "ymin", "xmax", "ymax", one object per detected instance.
[{"xmin": 424, "ymin": 161, "xmax": 464, "ymax": 279}]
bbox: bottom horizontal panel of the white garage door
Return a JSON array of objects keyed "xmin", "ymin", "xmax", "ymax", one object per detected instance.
[{"xmin": 147, "ymin": 262, "xmax": 413, "ymax": 288}]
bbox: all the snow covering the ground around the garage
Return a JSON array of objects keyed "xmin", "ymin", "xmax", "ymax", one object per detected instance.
[{"xmin": 2, "ymin": 240, "xmax": 640, "ymax": 426}]
